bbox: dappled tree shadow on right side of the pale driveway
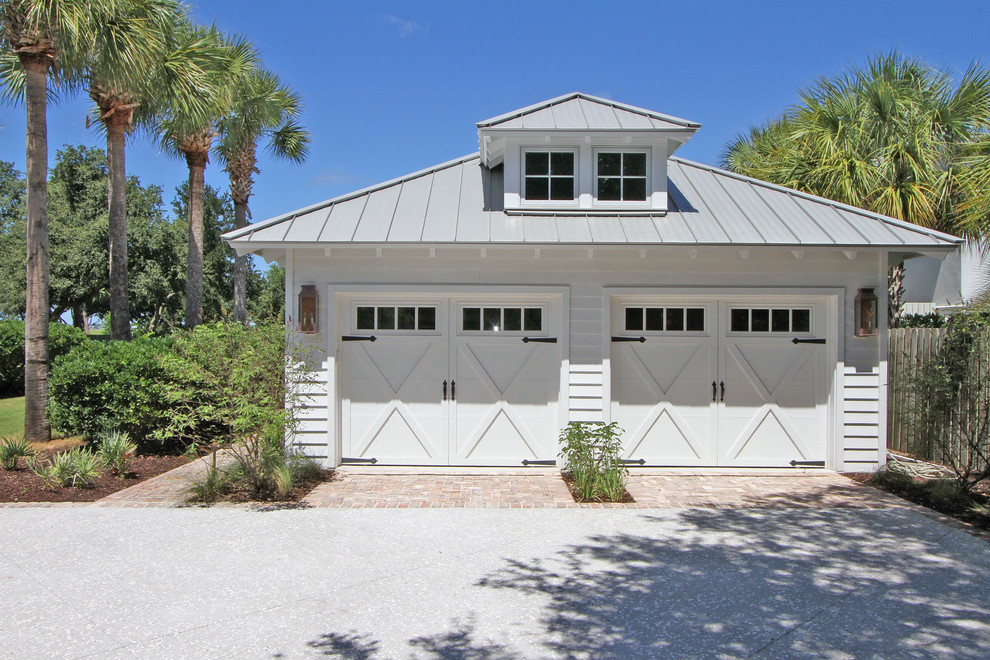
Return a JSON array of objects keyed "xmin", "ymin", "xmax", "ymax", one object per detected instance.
[{"xmin": 298, "ymin": 508, "xmax": 990, "ymax": 659}]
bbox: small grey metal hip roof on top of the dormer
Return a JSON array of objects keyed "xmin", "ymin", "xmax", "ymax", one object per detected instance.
[{"xmin": 478, "ymin": 92, "xmax": 701, "ymax": 131}]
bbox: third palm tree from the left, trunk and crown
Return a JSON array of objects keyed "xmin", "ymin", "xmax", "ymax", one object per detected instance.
[{"xmin": 154, "ymin": 25, "xmax": 257, "ymax": 328}]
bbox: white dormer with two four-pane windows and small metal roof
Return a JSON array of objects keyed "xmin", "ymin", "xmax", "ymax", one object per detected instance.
[{"xmin": 478, "ymin": 92, "xmax": 701, "ymax": 215}]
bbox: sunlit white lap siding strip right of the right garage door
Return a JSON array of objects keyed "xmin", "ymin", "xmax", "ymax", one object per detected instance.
[{"xmin": 842, "ymin": 367, "xmax": 885, "ymax": 472}]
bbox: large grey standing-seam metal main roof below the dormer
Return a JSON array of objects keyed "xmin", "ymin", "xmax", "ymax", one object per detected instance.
[{"xmin": 224, "ymin": 154, "xmax": 963, "ymax": 250}]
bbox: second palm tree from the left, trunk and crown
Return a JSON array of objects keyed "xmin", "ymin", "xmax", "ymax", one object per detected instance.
[{"xmin": 87, "ymin": 0, "xmax": 197, "ymax": 339}]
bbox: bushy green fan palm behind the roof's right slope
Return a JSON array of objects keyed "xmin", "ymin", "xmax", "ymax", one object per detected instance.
[{"xmin": 722, "ymin": 52, "xmax": 990, "ymax": 322}]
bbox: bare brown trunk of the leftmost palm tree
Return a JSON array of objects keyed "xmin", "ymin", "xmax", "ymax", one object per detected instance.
[{"xmin": 21, "ymin": 55, "xmax": 52, "ymax": 442}]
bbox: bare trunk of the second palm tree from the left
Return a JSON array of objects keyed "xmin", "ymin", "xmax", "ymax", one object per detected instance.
[{"xmin": 106, "ymin": 117, "xmax": 131, "ymax": 339}]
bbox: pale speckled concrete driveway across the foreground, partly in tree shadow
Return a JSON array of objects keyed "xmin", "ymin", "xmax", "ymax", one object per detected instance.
[{"xmin": 0, "ymin": 508, "xmax": 990, "ymax": 659}]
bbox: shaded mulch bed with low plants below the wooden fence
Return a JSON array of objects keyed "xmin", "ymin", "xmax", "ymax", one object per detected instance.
[{"xmin": 847, "ymin": 470, "xmax": 990, "ymax": 529}]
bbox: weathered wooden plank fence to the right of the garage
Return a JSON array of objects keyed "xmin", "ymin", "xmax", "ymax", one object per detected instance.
[{"xmin": 887, "ymin": 328, "xmax": 990, "ymax": 470}]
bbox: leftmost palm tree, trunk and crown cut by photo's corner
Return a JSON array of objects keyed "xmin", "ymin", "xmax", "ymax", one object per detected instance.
[{"xmin": 0, "ymin": 0, "xmax": 96, "ymax": 441}]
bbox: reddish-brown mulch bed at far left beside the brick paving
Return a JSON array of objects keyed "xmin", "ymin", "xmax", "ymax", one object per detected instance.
[{"xmin": 0, "ymin": 451, "xmax": 189, "ymax": 502}]
